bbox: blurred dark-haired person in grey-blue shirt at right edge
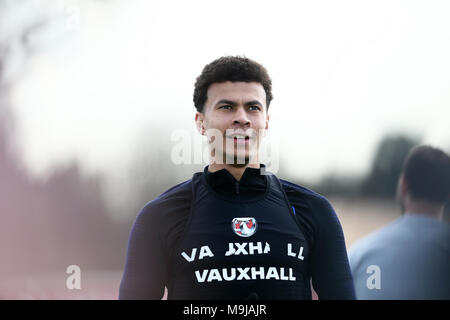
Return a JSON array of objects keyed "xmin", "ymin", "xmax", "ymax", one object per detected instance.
[{"xmin": 349, "ymin": 146, "xmax": 450, "ymax": 299}]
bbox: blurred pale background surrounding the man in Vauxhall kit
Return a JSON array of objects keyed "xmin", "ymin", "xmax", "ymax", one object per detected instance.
[{"xmin": 0, "ymin": 0, "xmax": 450, "ymax": 299}]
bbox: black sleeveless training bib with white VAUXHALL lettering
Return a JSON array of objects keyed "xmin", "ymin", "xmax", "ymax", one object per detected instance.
[{"xmin": 168, "ymin": 173, "xmax": 311, "ymax": 299}]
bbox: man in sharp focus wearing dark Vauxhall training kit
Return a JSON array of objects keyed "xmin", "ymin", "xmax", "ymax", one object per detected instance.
[{"xmin": 119, "ymin": 56, "xmax": 354, "ymax": 299}]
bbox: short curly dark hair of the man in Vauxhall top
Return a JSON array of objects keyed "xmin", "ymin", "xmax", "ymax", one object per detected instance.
[{"xmin": 194, "ymin": 56, "xmax": 273, "ymax": 112}]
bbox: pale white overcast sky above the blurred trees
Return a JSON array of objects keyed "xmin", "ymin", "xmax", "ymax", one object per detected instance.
[{"xmin": 4, "ymin": 0, "xmax": 450, "ymax": 198}]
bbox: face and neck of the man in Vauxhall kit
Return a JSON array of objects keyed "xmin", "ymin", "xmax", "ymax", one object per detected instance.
[{"xmin": 195, "ymin": 81, "xmax": 269, "ymax": 166}]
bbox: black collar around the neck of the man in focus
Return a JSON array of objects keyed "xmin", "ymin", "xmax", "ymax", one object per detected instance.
[{"xmin": 203, "ymin": 164, "xmax": 267, "ymax": 199}]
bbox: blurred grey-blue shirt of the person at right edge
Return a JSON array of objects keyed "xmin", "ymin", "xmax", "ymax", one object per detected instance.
[{"xmin": 349, "ymin": 214, "xmax": 450, "ymax": 300}]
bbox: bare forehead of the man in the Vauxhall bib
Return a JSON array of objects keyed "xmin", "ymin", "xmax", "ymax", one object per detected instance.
[{"xmin": 207, "ymin": 81, "xmax": 266, "ymax": 105}]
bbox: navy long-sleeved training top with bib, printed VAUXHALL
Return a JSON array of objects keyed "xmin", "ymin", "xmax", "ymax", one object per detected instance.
[{"xmin": 119, "ymin": 165, "xmax": 355, "ymax": 300}]
